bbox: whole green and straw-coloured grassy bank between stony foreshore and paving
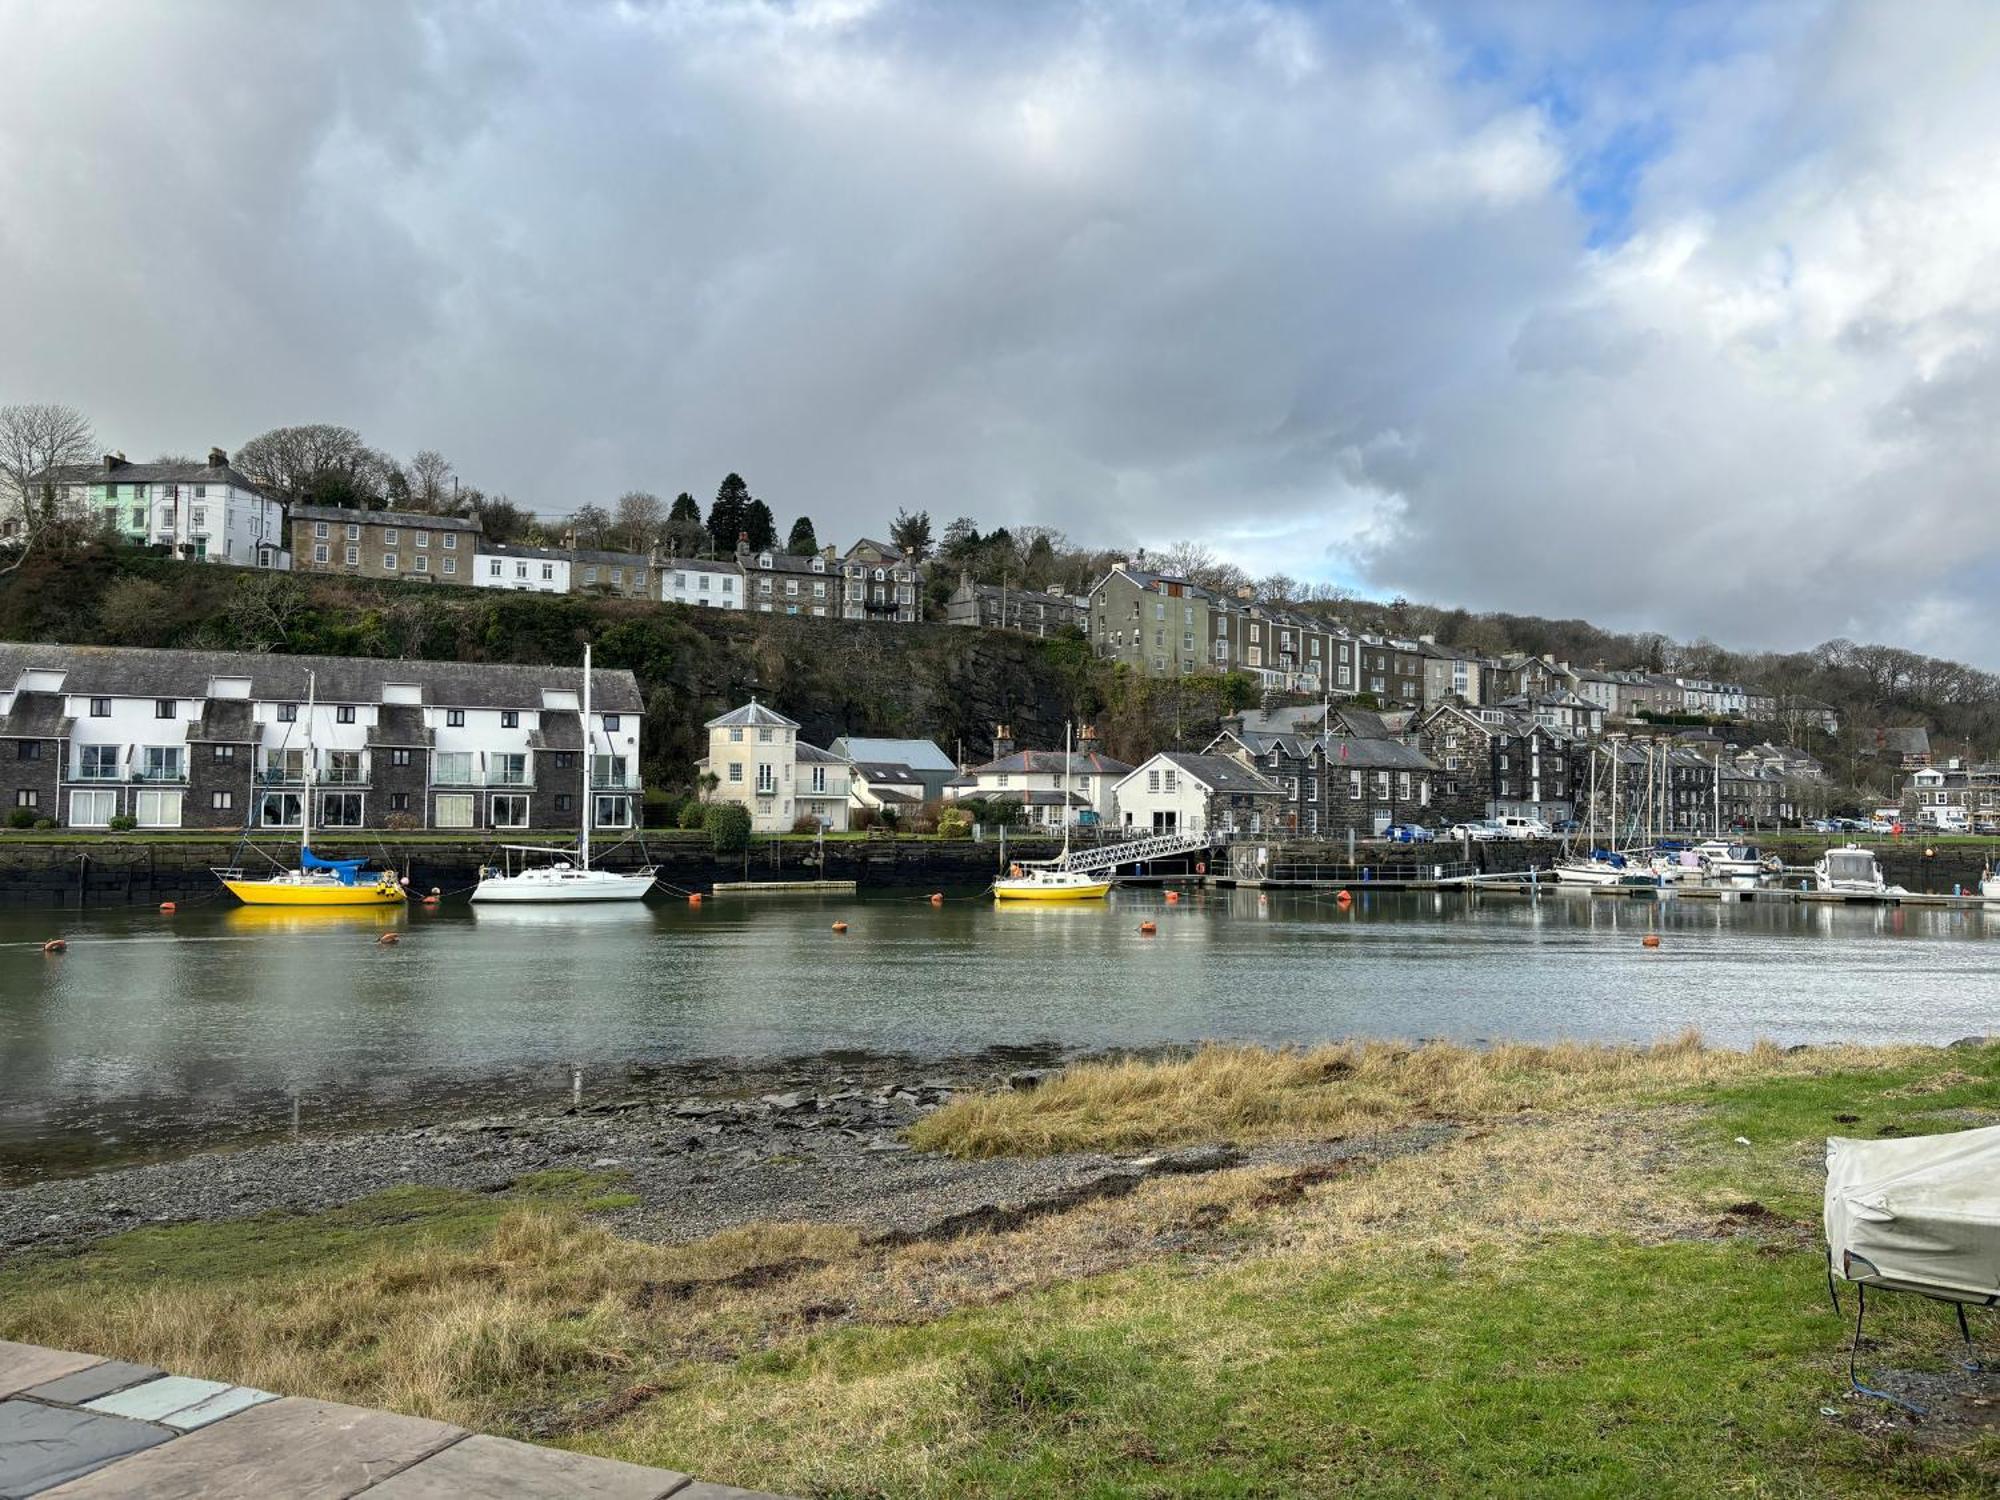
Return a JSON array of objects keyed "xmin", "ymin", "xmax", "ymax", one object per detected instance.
[{"xmin": 0, "ymin": 1038, "xmax": 2000, "ymax": 1500}]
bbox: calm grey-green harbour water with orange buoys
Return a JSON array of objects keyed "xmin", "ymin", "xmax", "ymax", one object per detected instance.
[{"xmin": 0, "ymin": 890, "xmax": 2000, "ymax": 1180}]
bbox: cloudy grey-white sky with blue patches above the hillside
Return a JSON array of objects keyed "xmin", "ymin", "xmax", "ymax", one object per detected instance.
[{"xmin": 0, "ymin": 0, "xmax": 2000, "ymax": 666}]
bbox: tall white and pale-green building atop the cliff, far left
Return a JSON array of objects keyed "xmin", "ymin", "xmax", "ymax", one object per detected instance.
[{"xmin": 44, "ymin": 448, "xmax": 292, "ymax": 570}]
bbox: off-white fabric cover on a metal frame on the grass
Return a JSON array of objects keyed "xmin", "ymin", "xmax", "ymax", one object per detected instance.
[{"xmin": 1826, "ymin": 1126, "xmax": 2000, "ymax": 1302}]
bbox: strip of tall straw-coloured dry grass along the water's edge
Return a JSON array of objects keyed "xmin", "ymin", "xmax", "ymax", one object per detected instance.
[{"xmin": 910, "ymin": 1030, "xmax": 1924, "ymax": 1156}]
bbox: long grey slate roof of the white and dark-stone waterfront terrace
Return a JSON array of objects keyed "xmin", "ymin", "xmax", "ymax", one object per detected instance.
[{"xmin": 0, "ymin": 642, "xmax": 644, "ymax": 714}]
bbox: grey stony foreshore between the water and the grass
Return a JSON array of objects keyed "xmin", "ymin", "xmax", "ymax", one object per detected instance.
[{"xmin": 0, "ymin": 1058, "xmax": 1448, "ymax": 1258}]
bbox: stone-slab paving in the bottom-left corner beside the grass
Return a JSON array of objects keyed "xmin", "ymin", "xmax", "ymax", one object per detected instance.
[{"xmin": 0, "ymin": 1340, "xmax": 776, "ymax": 1500}]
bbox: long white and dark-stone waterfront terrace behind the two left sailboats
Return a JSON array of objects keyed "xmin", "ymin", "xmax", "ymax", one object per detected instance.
[{"xmin": 0, "ymin": 644, "xmax": 642, "ymax": 832}]
